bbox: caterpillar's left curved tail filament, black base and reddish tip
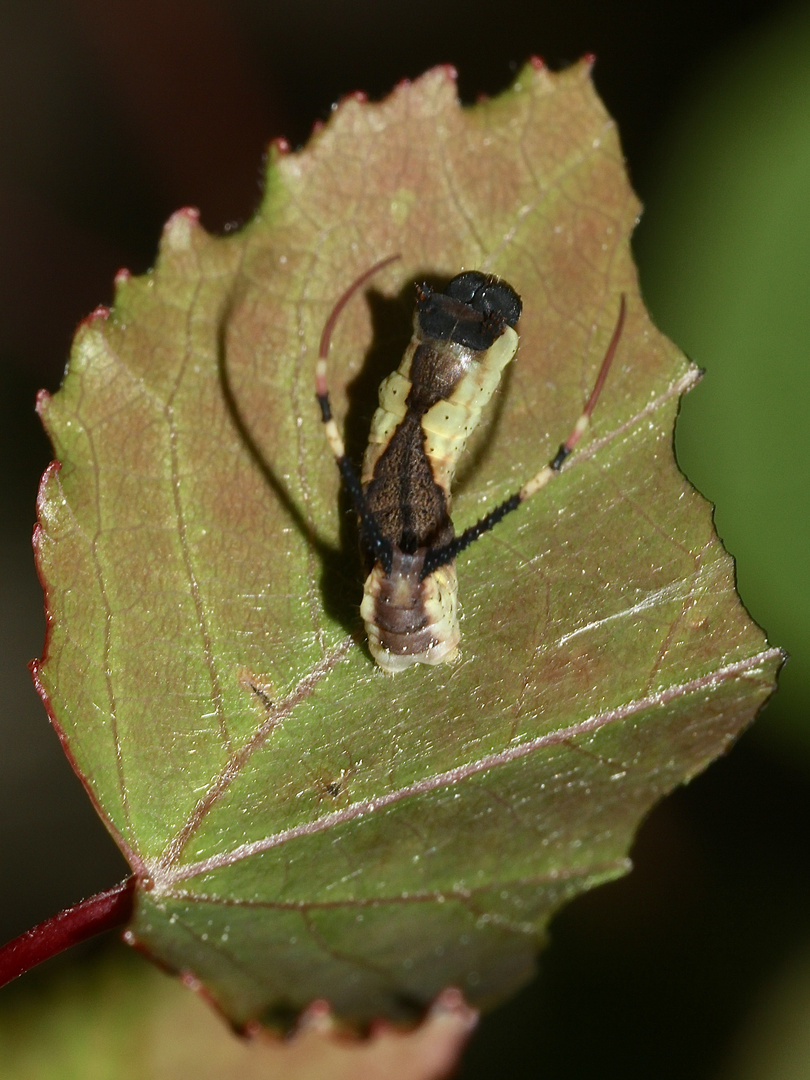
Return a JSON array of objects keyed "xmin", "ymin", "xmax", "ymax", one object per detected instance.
[{"xmin": 315, "ymin": 255, "xmax": 401, "ymax": 573}]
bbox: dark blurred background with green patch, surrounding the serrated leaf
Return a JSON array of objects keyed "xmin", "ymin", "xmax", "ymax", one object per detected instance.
[{"xmin": 0, "ymin": 0, "xmax": 810, "ymax": 1080}]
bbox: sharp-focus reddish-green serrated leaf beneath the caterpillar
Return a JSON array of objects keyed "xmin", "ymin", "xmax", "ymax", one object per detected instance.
[{"xmin": 37, "ymin": 65, "xmax": 780, "ymax": 1023}]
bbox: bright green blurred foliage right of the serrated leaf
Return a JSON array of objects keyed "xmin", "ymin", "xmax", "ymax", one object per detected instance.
[{"xmin": 637, "ymin": 4, "xmax": 810, "ymax": 766}]
